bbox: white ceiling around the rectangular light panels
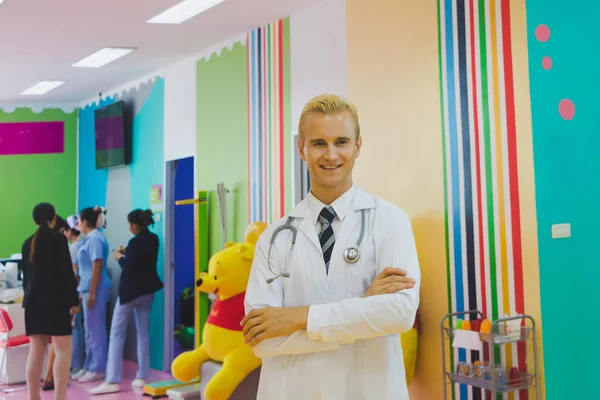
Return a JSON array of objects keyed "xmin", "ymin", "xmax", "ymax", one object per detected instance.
[{"xmin": 0, "ymin": 0, "xmax": 320, "ymax": 104}]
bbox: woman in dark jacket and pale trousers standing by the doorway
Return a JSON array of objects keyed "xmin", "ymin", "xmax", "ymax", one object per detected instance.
[{"xmin": 89, "ymin": 209, "xmax": 163, "ymax": 394}]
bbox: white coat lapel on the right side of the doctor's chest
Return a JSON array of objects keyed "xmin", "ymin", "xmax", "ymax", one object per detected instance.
[{"xmin": 325, "ymin": 187, "xmax": 375, "ymax": 293}]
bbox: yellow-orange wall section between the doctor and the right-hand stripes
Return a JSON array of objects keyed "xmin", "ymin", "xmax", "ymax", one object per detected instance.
[{"xmin": 347, "ymin": 0, "xmax": 448, "ymax": 399}]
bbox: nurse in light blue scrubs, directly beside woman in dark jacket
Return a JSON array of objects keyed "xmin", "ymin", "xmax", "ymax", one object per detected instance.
[{"xmin": 73, "ymin": 207, "xmax": 112, "ymax": 382}]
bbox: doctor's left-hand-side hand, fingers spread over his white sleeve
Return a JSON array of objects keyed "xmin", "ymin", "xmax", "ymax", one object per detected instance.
[{"xmin": 240, "ymin": 306, "xmax": 308, "ymax": 347}]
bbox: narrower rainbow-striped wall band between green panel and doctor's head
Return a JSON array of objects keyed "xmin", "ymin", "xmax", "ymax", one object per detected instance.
[{"xmin": 247, "ymin": 20, "xmax": 290, "ymax": 223}]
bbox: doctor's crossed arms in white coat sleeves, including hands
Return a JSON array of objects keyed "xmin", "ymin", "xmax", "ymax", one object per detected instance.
[{"xmin": 242, "ymin": 211, "xmax": 420, "ymax": 357}]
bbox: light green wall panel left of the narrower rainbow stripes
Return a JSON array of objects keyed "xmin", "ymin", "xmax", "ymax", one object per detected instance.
[{"xmin": 196, "ymin": 43, "xmax": 248, "ymax": 255}]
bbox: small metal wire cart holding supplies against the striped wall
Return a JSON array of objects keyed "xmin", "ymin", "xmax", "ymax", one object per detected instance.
[{"xmin": 440, "ymin": 310, "xmax": 540, "ymax": 400}]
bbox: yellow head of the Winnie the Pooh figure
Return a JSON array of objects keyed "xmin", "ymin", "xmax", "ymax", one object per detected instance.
[{"xmin": 196, "ymin": 243, "xmax": 254, "ymax": 297}]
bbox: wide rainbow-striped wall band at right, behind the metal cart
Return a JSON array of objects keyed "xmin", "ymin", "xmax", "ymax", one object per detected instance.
[{"xmin": 438, "ymin": 0, "xmax": 527, "ymax": 399}]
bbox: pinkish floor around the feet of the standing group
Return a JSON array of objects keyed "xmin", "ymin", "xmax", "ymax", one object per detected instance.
[{"xmin": 0, "ymin": 361, "xmax": 173, "ymax": 400}]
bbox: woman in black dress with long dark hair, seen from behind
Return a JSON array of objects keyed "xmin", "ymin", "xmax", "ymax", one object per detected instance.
[{"xmin": 21, "ymin": 203, "xmax": 79, "ymax": 400}]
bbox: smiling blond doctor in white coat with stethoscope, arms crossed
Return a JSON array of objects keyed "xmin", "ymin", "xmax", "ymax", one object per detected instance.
[{"xmin": 241, "ymin": 95, "xmax": 421, "ymax": 400}]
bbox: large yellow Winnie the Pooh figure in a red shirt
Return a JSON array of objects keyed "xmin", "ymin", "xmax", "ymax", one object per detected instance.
[{"xmin": 171, "ymin": 223, "xmax": 266, "ymax": 400}]
